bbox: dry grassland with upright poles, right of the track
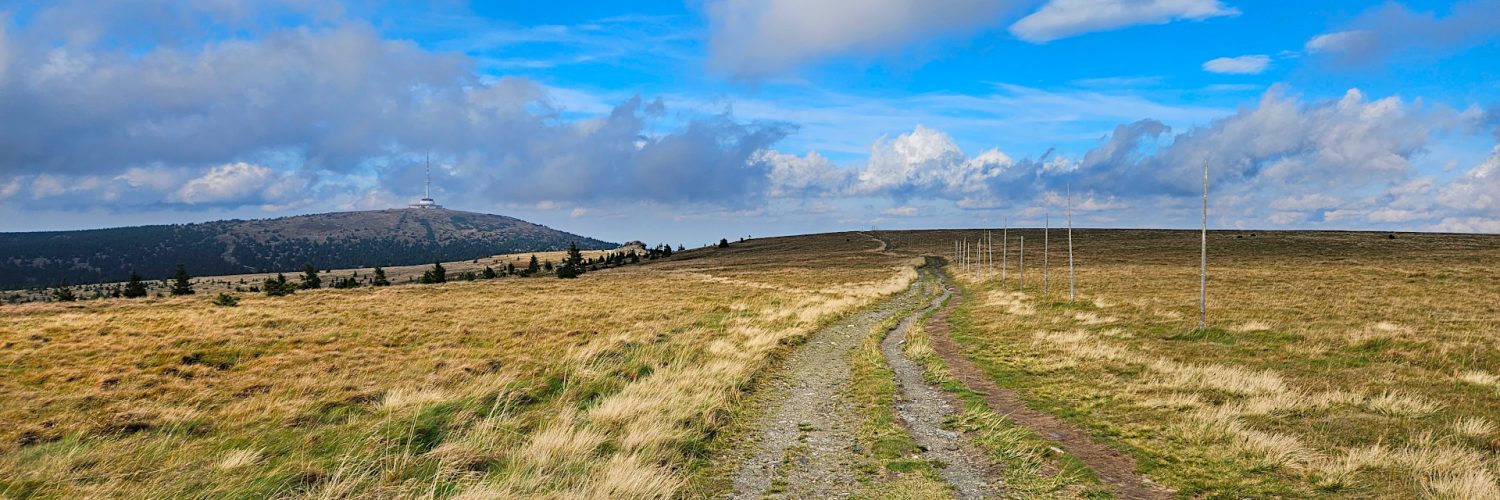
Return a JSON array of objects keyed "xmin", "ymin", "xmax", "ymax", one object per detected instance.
[{"xmin": 881, "ymin": 230, "xmax": 1500, "ymax": 498}]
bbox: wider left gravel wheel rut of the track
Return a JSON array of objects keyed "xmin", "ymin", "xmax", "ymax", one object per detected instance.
[{"xmin": 732, "ymin": 276, "xmax": 920, "ymax": 498}]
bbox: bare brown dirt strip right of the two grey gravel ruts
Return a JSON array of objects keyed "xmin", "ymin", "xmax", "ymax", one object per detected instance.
[{"xmin": 927, "ymin": 273, "xmax": 1170, "ymax": 498}]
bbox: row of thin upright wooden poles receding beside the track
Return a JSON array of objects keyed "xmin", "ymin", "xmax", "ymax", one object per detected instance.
[{"xmin": 953, "ymin": 161, "xmax": 1209, "ymax": 330}]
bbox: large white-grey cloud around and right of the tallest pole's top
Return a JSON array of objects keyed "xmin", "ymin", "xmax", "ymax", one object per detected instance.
[{"xmin": 1080, "ymin": 87, "xmax": 1451, "ymax": 194}]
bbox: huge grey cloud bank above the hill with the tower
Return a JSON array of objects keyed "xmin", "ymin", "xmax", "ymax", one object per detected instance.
[{"xmin": 0, "ymin": 3, "xmax": 794, "ymax": 209}]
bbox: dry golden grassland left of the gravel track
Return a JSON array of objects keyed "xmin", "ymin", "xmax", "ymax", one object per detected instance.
[{"xmin": 0, "ymin": 234, "xmax": 915, "ymax": 498}]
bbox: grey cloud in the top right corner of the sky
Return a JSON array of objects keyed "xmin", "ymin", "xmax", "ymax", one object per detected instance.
[{"xmin": 1307, "ymin": 0, "xmax": 1500, "ymax": 66}]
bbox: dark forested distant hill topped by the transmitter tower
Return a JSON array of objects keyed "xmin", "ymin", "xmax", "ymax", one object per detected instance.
[{"xmin": 0, "ymin": 209, "xmax": 617, "ymax": 290}]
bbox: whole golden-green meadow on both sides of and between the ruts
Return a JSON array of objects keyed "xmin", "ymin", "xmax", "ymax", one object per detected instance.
[{"xmin": 0, "ymin": 230, "xmax": 1500, "ymax": 498}]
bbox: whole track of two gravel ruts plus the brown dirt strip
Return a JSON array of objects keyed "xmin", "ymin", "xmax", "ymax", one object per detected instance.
[{"xmin": 731, "ymin": 234, "xmax": 1172, "ymax": 498}]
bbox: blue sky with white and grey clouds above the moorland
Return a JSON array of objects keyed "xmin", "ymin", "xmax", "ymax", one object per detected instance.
[{"xmin": 0, "ymin": 0, "xmax": 1500, "ymax": 245}]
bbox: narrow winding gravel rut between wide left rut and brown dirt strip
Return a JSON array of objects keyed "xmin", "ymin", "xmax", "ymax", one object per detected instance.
[{"xmin": 881, "ymin": 262, "xmax": 996, "ymax": 498}]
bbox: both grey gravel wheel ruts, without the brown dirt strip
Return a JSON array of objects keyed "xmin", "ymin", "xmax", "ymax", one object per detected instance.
[{"xmin": 732, "ymin": 258, "xmax": 995, "ymax": 498}]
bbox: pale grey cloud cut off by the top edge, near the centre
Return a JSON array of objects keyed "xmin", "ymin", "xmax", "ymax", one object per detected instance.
[{"xmin": 705, "ymin": 0, "xmax": 1013, "ymax": 77}]
